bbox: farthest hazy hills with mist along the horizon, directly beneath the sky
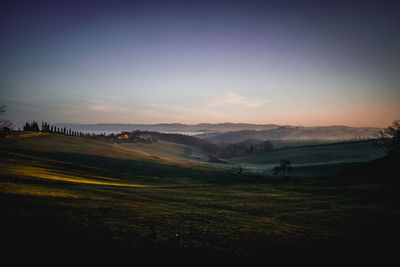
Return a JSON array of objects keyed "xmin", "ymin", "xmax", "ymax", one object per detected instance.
[{"xmin": 16, "ymin": 123, "xmax": 381, "ymax": 140}]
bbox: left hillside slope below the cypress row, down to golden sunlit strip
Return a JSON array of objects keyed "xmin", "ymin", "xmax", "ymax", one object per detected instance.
[{"xmin": 0, "ymin": 133, "xmax": 216, "ymax": 187}]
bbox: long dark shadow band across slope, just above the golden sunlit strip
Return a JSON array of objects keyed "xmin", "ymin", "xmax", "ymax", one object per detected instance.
[{"xmin": 0, "ymin": 149, "xmax": 282, "ymax": 184}]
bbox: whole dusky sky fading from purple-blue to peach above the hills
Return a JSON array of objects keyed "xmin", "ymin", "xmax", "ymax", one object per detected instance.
[{"xmin": 0, "ymin": 0, "xmax": 400, "ymax": 127}]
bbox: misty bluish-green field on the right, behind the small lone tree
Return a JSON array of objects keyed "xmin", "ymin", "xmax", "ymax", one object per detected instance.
[{"xmin": 229, "ymin": 141, "xmax": 384, "ymax": 177}]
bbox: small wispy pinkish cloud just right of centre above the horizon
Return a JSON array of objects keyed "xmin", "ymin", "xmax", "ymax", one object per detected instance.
[{"xmin": 206, "ymin": 92, "xmax": 271, "ymax": 108}]
